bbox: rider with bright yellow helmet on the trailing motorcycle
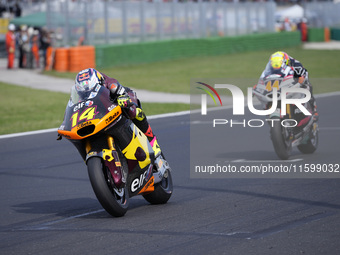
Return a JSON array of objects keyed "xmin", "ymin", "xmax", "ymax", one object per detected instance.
[{"xmin": 269, "ymin": 51, "xmax": 318, "ymax": 119}]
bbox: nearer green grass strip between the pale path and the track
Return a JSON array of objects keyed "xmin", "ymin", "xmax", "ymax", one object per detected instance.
[{"xmin": 0, "ymin": 82, "xmax": 189, "ymax": 134}]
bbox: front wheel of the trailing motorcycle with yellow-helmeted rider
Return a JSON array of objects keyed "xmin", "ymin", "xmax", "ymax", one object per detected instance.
[{"xmin": 270, "ymin": 118, "xmax": 292, "ymax": 160}]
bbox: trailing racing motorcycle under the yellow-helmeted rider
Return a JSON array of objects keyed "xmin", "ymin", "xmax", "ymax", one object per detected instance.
[{"xmin": 253, "ymin": 65, "xmax": 319, "ymax": 160}]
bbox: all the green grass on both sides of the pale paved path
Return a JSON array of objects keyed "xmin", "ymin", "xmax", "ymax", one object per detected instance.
[{"xmin": 0, "ymin": 47, "xmax": 340, "ymax": 134}]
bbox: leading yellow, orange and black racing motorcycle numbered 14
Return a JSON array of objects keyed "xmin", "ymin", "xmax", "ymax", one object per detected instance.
[{"xmin": 58, "ymin": 82, "xmax": 173, "ymax": 217}]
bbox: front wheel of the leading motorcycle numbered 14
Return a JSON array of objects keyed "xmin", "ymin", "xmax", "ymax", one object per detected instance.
[{"xmin": 87, "ymin": 157, "xmax": 129, "ymax": 217}]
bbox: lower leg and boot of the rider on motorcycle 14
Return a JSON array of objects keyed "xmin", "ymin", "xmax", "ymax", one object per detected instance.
[{"xmin": 133, "ymin": 107, "xmax": 162, "ymax": 158}]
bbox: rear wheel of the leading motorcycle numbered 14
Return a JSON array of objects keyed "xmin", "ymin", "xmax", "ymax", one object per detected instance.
[{"xmin": 143, "ymin": 170, "xmax": 173, "ymax": 204}]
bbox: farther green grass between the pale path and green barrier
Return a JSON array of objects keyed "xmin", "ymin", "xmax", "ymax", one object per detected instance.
[{"xmin": 48, "ymin": 47, "xmax": 340, "ymax": 94}]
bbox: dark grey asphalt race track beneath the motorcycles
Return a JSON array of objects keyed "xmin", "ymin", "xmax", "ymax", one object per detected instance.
[{"xmin": 0, "ymin": 95, "xmax": 340, "ymax": 255}]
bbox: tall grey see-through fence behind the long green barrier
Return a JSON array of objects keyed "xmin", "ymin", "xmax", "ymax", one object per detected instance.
[{"xmin": 42, "ymin": 0, "xmax": 276, "ymax": 46}]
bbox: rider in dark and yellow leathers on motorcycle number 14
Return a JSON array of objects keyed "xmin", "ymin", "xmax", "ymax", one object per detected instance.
[{"xmin": 75, "ymin": 68, "xmax": 161, "ymax": 158}]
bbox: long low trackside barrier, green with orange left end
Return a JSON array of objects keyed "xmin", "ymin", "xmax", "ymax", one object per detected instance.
[{"xmin": 53, "ymin": 32, "xmax": 301, "ymax": 72}]
